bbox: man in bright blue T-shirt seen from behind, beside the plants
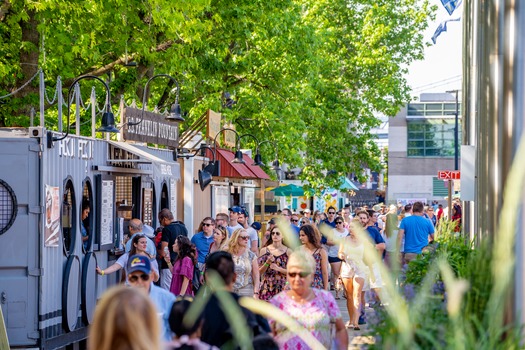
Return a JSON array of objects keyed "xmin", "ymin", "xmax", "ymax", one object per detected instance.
[{"xmin": 397, "ymin": 202, "xmax": 434, "ymax": 264}]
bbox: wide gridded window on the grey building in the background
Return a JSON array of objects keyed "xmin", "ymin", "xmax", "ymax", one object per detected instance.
[{"xmin": 407, "ymin": 118, "xmax": 461, "ymax": 157}]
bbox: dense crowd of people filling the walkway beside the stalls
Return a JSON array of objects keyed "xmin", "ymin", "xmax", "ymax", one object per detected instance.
[{"xmin": 88, "ymin": 202, "xmax": 450, "ymax": 349}]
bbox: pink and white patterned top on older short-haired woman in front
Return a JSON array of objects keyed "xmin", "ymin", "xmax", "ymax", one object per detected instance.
[{"xmin": 270, "ymin": 288, "xmax": 341, "ymax": 350}]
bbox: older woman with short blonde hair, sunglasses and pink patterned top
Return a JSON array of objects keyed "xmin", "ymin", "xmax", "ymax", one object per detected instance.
[{"xmin": 270, "ymin": 250, "xmax": 348, "ymax": 350}]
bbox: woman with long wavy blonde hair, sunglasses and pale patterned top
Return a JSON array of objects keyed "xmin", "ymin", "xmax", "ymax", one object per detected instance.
[{"xmin": 226, "ymin": 228, "xmax": 260, "ymax": 299}]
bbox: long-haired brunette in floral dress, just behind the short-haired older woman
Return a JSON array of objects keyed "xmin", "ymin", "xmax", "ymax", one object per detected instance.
[{"xmin": 299, "ymin": 224, "xmax": 330, "ymax": 290}]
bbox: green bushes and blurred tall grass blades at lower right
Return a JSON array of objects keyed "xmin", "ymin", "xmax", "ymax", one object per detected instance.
[{"xmin": 370, "ymin": 135, "xmax": 525, "ymax": 350}]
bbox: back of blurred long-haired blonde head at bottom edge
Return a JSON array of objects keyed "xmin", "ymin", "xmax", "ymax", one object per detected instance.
[{"xmin": 88, "ymin": 286, "xmax": 161, "ymax": 350}]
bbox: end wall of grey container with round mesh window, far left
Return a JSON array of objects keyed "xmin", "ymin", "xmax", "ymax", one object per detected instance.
[{"xmin": 0, "ymin": 139, "xmax": 41, "ymax": 346}]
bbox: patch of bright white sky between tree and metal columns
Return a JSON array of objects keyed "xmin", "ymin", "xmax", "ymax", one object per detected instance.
[{"xmin": 407, "ymin": 0, "xmax": 463, "ymax": 97}]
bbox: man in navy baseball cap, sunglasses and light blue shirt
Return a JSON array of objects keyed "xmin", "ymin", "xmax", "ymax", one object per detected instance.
[{"xmin": 127, "ymin": 255, "xmax": 175, "ymax": 341}]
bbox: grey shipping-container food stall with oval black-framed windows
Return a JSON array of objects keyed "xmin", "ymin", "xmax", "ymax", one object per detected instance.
[{"xmin": 0, "ymin": 117, "xmax": 180, "ymax": 349}]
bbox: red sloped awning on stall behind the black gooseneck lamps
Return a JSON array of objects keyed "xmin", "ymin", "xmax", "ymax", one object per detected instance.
[{"xmin": 206, "ymin": 148, "xmax": 270, "ymax": 180}]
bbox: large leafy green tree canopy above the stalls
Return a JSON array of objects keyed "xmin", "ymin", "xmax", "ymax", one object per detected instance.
[{"xmin": 0, "ymin": 0, "xmax": 433, "ymax": 189}]
